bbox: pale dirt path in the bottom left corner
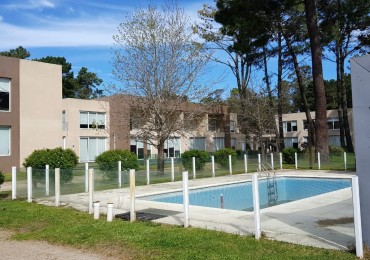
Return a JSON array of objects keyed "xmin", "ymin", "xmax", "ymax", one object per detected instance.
[{"xmin": 0, "ymin": 229, "xmax": 112, "ymax": 260}]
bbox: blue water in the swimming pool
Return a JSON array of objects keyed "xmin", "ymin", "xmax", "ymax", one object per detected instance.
[{"xmin": 141, "ymin": 177, "xmax": 351, "ymax": 211}]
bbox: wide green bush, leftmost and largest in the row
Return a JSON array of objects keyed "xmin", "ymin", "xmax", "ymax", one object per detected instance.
[{"xmin": 23, "ymin": 147, "xmax": 78, "ymax": 184}]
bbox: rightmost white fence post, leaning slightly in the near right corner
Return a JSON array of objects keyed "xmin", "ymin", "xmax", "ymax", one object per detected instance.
[{"xmin": 352, "ymin": 176, "xmax": 364, "ymax": 258}]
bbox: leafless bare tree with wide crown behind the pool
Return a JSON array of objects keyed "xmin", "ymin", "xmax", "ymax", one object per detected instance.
[{"xmin": 112, "ymin": 4, "xmax": 209, "ymax": 172}]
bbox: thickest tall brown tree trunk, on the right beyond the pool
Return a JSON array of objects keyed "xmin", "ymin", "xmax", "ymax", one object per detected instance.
[{"xmin": 304, "ymin": 0, "xmax": 329, "ymax": 162}]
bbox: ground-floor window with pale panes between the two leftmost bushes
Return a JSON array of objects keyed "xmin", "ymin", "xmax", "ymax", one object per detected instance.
[{"xmin": 80, "ymin": 137, "xmax": 106, "ymax": 162}]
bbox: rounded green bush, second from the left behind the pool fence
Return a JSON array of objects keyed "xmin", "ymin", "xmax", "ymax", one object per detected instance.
[{"xmin": 95, "ymin": 149, "xmax": 139, "ymax": 180}]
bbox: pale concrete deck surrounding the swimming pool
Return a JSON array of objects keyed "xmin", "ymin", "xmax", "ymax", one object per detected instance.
[{"xmin": 38, "ymin": 170, "xmax": 355, "ymax": 250}]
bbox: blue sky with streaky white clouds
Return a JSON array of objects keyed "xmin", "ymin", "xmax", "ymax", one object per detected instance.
[{"xmin": 0, "ymin": 0, "xmax": 342, "ymax": 96}]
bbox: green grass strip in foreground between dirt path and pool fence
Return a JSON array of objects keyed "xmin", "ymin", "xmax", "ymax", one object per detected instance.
[{"xmin": 0, "ymin": 199, "xmax": 356, "ymax": 260}]
